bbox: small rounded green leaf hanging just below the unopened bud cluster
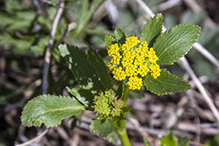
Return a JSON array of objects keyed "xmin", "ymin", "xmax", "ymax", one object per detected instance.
[{"xmin": 90, "ymin": 119, "xmax": 114, "ymax": 137}]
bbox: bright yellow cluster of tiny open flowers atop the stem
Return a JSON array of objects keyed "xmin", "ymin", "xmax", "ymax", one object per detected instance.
[{"xmin": 107, "ymin": 36, "xmax": 161, "ymax": 90}]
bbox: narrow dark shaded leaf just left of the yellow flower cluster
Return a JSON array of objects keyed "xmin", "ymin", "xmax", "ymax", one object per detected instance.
[{"xmin": 88, "ymin": 45, "xmax": 112, "ymax": 89}]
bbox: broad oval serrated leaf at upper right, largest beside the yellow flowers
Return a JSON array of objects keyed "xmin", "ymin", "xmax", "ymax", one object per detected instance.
[{"xmin": 153, "ymin": 24, "xmax": 201, "ymax": 65}]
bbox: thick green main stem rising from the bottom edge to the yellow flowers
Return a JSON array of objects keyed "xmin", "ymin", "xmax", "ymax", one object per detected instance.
[{"xmin": 114, "ymin": 85, "xmax": 131, "ymax": 146}]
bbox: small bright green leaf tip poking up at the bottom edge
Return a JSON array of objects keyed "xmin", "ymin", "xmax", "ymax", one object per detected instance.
[{"xmin": 160, "ymin": 133, "xmax": 177, "ymax": 146}]
